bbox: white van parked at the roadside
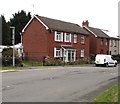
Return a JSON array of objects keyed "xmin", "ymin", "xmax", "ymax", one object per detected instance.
[{"xmin": 95, "ymin": 54, "xmax": 117, "ymax": 66}]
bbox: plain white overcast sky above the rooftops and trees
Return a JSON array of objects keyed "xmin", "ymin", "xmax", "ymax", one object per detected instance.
[{"xmin": 0, "ymin": 0, "xmax": 120, "ymax": 37}]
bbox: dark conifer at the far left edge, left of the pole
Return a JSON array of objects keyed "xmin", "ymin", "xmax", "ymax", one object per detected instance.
[{"xmin": 1, "ymin": 16, "xmax": 11, "ymax": 45}]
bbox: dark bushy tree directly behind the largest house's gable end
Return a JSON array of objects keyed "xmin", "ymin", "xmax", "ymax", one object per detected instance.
[{"xmin": 10, "ymin": 10, "xmax": 31, "ymax": 44}]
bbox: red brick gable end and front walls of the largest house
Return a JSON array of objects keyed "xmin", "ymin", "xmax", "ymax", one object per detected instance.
[{"xmin": 23, "ymin": 18, "xmax": 89, "ymax": 61}]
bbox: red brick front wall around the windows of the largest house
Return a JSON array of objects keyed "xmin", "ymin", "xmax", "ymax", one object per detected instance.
[{"xmin": 48, "ymin": 31, "xmax": 89, "ymax": 58}]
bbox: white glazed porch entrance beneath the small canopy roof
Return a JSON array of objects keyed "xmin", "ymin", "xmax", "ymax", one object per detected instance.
[{"xmin": 63, "ymin": 50, "xmax": 76, "ymax": 62}]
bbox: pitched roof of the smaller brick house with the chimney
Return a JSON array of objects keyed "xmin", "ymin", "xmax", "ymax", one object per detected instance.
[{"xmin": 87, "ymin": 27, "xmax": 110, "ymax": 38}]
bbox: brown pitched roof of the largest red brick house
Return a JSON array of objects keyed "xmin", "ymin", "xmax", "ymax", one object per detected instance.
[{"xmin": 36, "ymin": 15, "xmax": 89, "ymax": 35}]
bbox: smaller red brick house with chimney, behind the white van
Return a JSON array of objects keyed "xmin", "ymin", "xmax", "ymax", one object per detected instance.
[{"xmin": 82, "ymin": 21, "xmax": 110, "ymax": 55}]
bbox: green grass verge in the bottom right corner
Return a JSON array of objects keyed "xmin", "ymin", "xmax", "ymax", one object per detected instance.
[{"xmin": 93, "ymin": 84, "xmax": 120, "ymax": 104}]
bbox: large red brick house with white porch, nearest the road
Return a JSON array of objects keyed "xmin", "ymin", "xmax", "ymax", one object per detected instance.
[{"xmin": 22, "ymin": 15, "xmax": 89, "ymax": 62}]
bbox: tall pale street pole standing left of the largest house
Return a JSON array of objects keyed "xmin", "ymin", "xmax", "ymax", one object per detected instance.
[{"xmin": 10, "ymin": 26, "xmax": 15, "ymax": 66}]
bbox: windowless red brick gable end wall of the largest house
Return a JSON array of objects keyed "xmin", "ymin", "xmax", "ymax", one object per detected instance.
[{"xmin": 23, "ymin": 18, "xmax": 48, "ymax": 61}]
